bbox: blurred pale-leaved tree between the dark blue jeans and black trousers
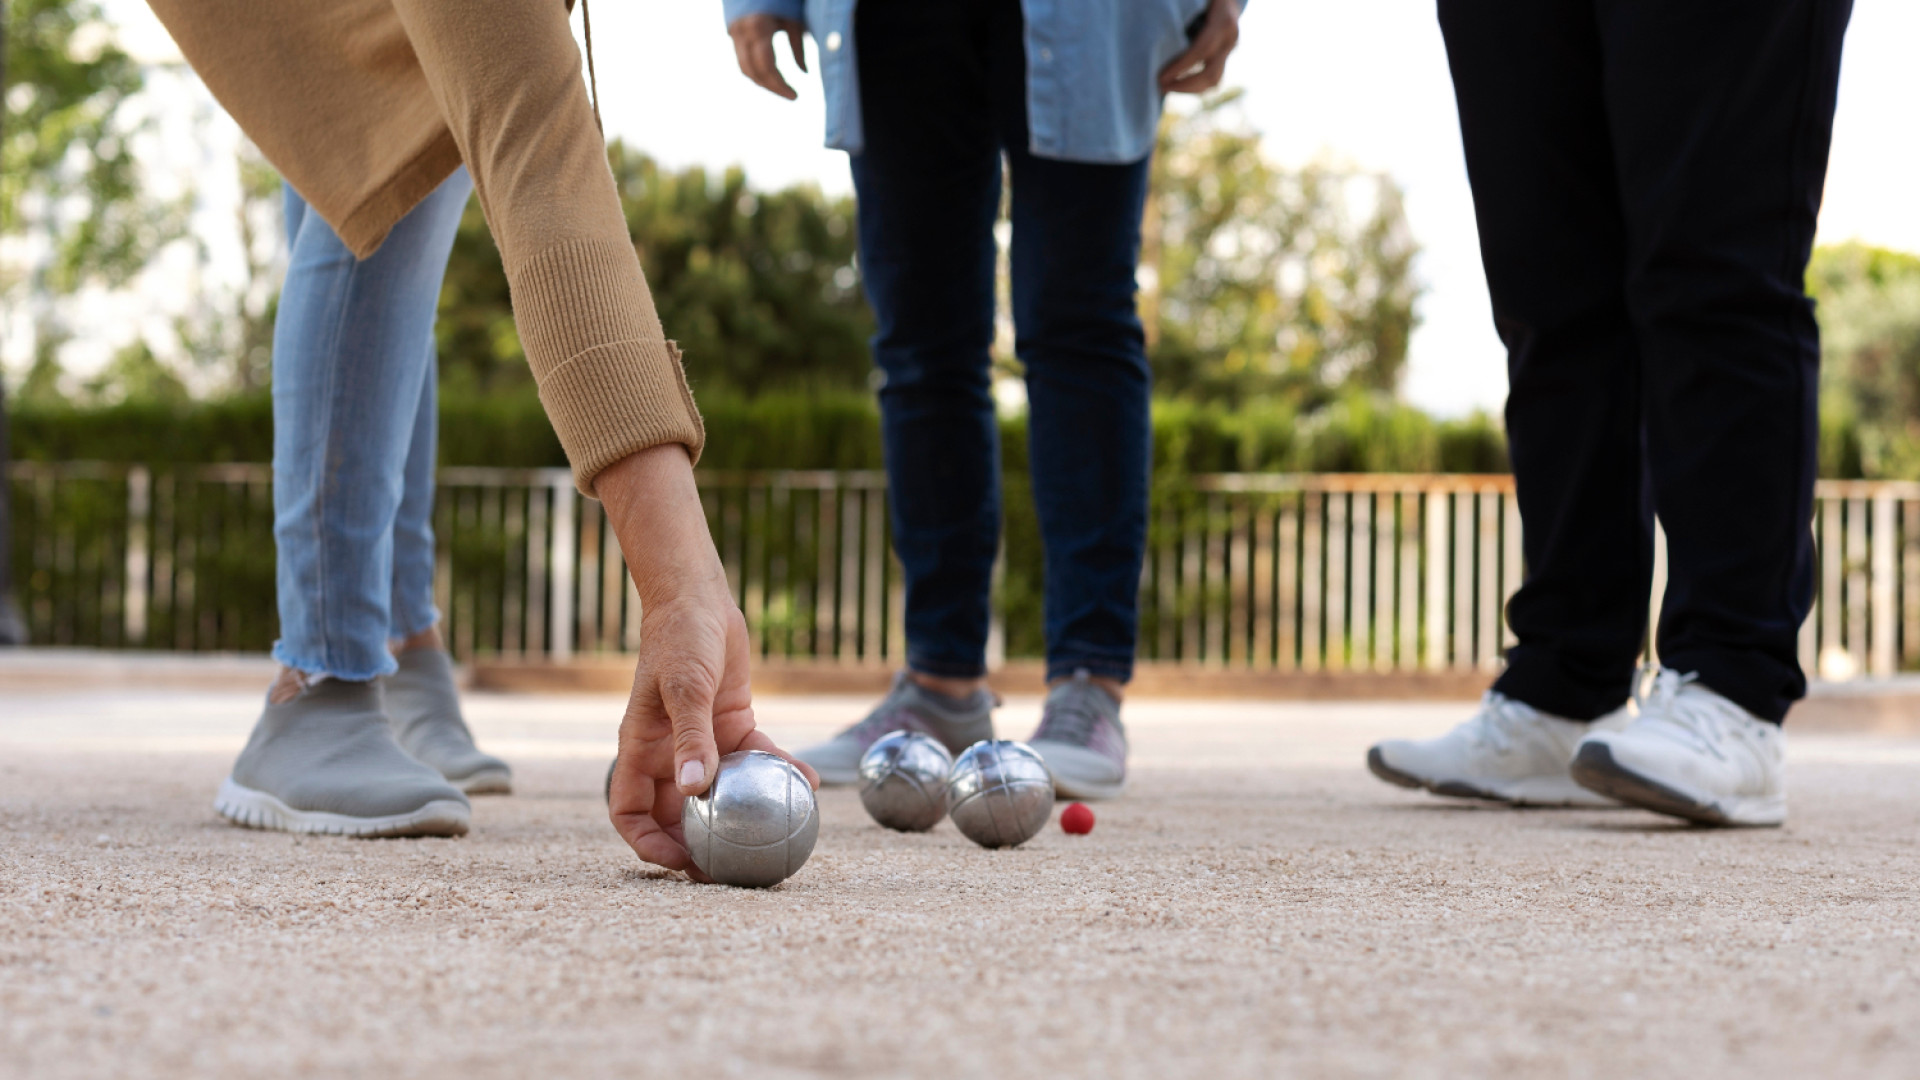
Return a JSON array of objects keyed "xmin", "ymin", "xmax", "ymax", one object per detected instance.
[{"xmin": 1140, "ymin": 90, "xmax": 1421, "ymax": 411}]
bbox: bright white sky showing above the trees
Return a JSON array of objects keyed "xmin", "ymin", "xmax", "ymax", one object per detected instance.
[{"xmin": 97, "ymin": 0, "xmax": 1920, "ymax": 413}]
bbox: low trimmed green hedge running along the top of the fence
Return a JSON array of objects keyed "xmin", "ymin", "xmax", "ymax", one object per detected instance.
[{"xmin": 12, "ymin": 392, "xmax": 1507, "ymax": 473}]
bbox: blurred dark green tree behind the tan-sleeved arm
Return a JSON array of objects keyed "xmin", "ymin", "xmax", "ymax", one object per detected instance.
[{"xmin": 438, "ymin": 142, "xmax": 874, "ymax": 396}]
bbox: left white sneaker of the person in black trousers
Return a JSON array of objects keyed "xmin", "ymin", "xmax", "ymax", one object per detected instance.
[{"xmin": 1367, "ymin": 690, "xmax": 1630, "ymax": 807}]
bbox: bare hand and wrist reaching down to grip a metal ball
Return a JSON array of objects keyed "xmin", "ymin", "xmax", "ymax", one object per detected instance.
[{"xmin": 593, "ymin": 446, "xmax": 820, "ymax": 880}]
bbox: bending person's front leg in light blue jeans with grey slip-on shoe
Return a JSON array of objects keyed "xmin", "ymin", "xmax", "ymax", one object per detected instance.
[{"xmin": 213, "ymin": 173, "xmax": 470, "ymax": 836}]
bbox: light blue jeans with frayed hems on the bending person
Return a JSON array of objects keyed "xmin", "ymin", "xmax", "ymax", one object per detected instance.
[{"xmin": 273, "ymin": 169, "xmax": 472, "ymax": 680}]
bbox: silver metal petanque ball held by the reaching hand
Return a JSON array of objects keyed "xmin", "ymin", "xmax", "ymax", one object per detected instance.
[{"xmin": 682, "ymin": 749, "xmax": 820, "ymax": 888}]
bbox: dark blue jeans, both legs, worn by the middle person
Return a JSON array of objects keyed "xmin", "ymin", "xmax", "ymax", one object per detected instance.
[{"xmin": 852, "ymin": 0, "xmax": 1152, "ymax": 680}]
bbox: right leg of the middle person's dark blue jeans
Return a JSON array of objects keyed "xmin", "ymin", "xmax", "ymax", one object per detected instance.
[{"xmin": 991, "ymin": 4, "xmax": 1152, "ymax": 682}]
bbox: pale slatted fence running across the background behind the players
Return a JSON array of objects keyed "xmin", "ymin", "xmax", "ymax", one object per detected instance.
[{"xmin": 10, "ymin": 461, "xmax": 1920, "ymax": 678}]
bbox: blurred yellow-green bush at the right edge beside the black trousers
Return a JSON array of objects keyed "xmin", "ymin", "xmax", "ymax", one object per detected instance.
[{"xmin": 1807, "ymin": 242, "xmax": 1920, "ymax": 480}]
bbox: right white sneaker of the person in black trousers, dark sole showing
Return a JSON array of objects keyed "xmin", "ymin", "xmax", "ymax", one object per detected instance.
[{"xmin": 1572, "ymin": 669, "xmax": 1788, "ymax": 826}]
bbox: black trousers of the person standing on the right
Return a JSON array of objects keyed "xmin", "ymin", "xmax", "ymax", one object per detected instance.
[{"xmin": 1440, "ymin": 0, "xmax": 1851, "ymax": 721}]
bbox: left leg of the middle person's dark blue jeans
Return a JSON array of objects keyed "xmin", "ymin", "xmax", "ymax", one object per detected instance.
[{"xmin": 852, "ymin": 0, "xmax": 1000, "ymax": 678}]
